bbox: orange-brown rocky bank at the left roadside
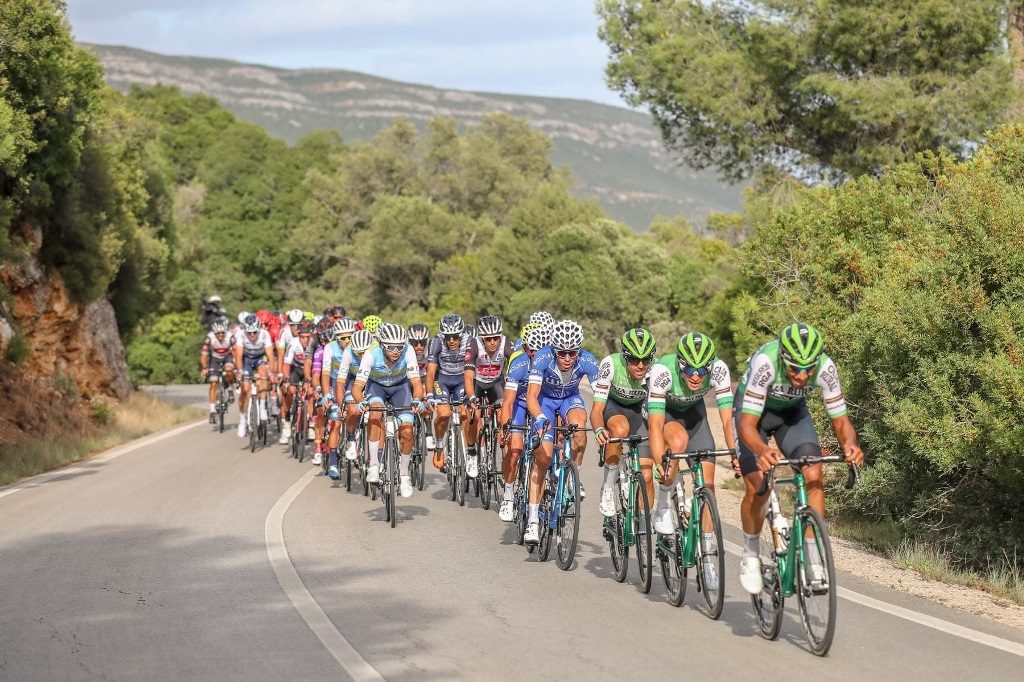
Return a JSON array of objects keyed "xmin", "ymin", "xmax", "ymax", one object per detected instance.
[{"xmin": 0, "ymin": 228, "xmax": 132, "ymax": 441}]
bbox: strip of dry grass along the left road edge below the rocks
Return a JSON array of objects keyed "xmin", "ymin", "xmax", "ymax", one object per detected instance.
[{"xmin": 0, "ymin": 393, "xmax": 205, "ymax": 485}]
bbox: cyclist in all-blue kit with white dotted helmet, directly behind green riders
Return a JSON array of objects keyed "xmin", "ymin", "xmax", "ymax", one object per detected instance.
[{"xmin": 524, "ymin": 319, "xmax": 598, "ymax": 544}]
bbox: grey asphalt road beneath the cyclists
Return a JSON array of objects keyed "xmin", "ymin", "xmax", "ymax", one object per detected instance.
[{"xmin": 0, "ymin": 389, "xmax": 1024, "ymax": 682}]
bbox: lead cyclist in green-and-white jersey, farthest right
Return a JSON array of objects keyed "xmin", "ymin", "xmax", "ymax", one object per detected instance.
[{"xmin": 733, "ymin": 323, "xmax": 864, "ymax": 594}]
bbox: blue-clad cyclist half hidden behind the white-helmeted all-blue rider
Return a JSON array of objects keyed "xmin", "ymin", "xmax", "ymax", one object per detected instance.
[{"xmin": 498, "ymin": 325, "xmax": 551, "ymax": 522}]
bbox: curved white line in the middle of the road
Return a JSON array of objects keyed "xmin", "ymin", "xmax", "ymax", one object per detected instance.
[{"xmin": 264, "ymin": 469, "xmax": 384, "ymax": 680}]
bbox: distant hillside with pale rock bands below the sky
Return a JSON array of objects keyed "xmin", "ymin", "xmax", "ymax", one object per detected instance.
[{"xmin": 85, "ymin": 45, "xmax": 740, "ymax": 229}]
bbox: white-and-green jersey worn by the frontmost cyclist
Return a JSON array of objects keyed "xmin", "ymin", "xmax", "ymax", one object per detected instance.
[{"xmin": 737, "ymin": 340, "xmax": 846, "ymax": 419}]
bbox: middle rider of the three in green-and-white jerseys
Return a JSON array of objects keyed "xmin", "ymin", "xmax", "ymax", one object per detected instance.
[{"xmin": 647, "ymin": 332, "xmax": 735, "ymax": 590}]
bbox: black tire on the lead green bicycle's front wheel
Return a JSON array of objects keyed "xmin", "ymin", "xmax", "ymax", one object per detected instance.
[{"xmin": 791, "ymin": 507, "xmax": 837, "ymax": 656}]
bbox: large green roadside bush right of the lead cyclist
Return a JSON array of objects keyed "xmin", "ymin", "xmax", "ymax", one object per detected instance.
[{"xmin": 731, "ymin": 126, "xmax": 1024, "ymax": 566}]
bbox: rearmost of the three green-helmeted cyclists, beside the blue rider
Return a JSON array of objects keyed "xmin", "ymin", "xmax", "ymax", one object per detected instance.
[{"xmin": 590, "ymin": 327, "xmax": 657, "ymax": 516}]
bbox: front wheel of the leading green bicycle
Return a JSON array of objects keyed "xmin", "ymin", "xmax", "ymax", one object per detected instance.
[{"xmin": 791, "ymin": 507, "xmax": 836, "ymax": 656}]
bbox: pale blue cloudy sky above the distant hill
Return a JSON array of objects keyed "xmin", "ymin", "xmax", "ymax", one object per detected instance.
[{"xmin": 67, "ymin": 0, "xmax": 625, "ymax": 105}]
